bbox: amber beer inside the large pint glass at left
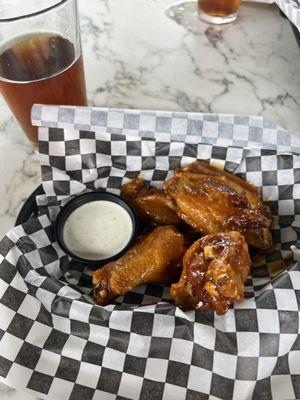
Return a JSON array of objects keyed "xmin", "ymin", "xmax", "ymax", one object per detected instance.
[{"xmin": 0, "ymin": 33, "xmax": 87, "ymax": 145}]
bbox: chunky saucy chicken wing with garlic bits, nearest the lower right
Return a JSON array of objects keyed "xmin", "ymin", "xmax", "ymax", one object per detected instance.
[{"xmin": 170, "ymin": 231, "xmax": 250, "ymax": 315}]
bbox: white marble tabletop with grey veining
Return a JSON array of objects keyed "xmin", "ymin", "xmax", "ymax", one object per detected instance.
[{"xmin": 0, "ymin": 0, "xmax": 300, "ymax": 400}]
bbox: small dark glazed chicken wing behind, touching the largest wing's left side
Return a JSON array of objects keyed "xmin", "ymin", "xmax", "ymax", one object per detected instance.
[{"xmin": 121, "ymin": 178, "xmax": 180, "ymax": 225}]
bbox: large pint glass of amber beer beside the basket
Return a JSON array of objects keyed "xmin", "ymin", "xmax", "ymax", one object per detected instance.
[{"xmin": 0, "ymin": 0, "xmax": 87, "ymax": 146}]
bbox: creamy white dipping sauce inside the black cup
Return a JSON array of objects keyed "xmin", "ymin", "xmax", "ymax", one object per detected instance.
[{"xmin": 63, "ymin": 200, "xmax": 133, "ymax": 260}]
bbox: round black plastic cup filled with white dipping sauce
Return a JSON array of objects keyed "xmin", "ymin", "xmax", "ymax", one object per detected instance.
[{"xmin": 55, "ymin": 192, "xmax": 138, "ymax": 267}]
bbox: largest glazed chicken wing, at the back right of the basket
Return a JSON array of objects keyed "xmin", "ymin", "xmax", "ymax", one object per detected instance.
[{"xmin": 164, "ymin": 161, "xmax": 272, "ymax": 249}]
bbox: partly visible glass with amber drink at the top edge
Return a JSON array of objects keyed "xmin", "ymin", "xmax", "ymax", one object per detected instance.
[{"xmin": 198, "ymin": 0, "xmax": 240, "ymax": 24}]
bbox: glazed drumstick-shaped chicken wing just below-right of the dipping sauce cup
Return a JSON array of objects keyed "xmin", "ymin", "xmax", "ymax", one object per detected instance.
[{"xmin": 93, "ymin": 226, "xmax": 185, "ymax": 305}]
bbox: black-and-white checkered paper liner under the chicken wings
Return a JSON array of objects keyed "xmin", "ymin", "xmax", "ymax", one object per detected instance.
[{"xmin": 0, "ymin": 106, "xmax": 300, "ymax": 400}]
